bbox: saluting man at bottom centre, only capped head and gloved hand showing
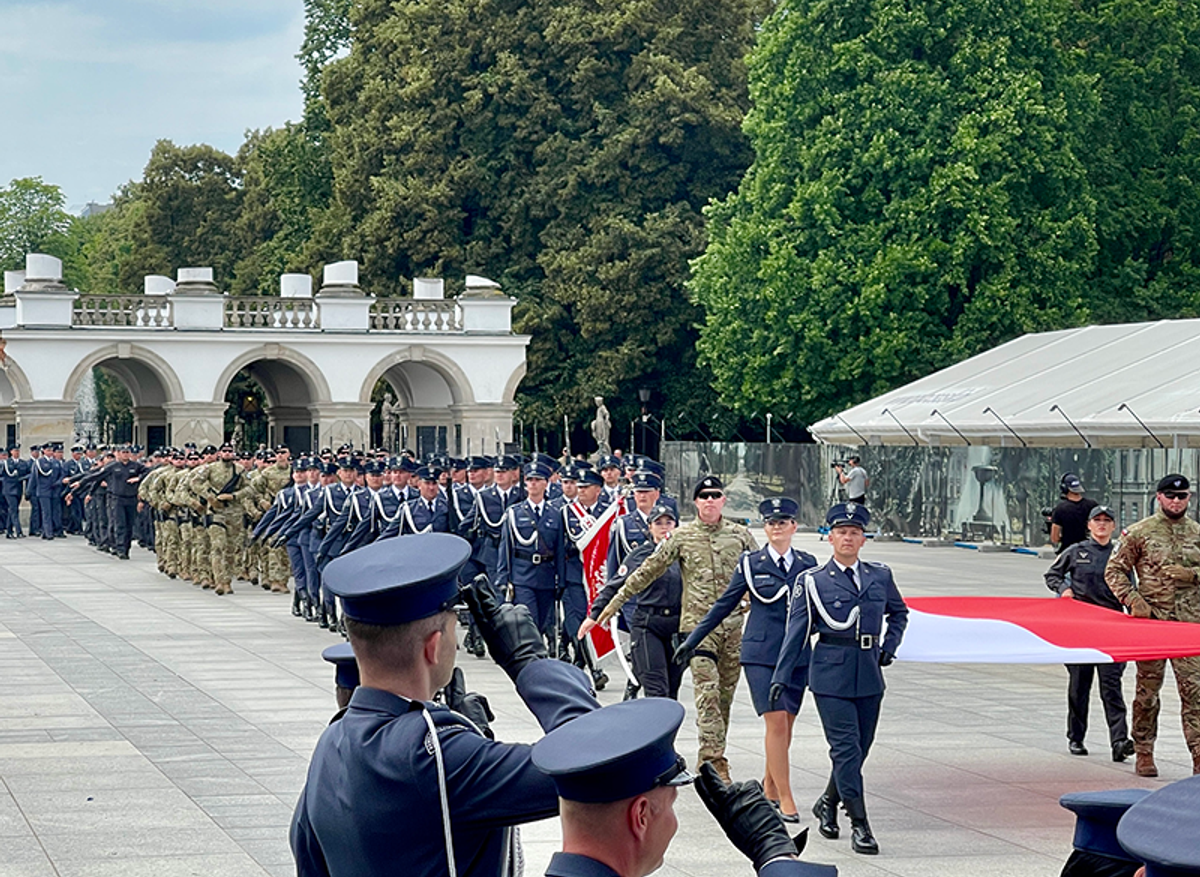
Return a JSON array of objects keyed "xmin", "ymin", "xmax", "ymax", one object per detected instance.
[{"xmin": 533, "ymin": 697, "xmax": 838, "ymax": 877}]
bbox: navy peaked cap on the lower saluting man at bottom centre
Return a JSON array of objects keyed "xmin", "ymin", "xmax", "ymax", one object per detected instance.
[{"xmin": 530, "ymin": 700, "xmax": 696, "ymax": 804}]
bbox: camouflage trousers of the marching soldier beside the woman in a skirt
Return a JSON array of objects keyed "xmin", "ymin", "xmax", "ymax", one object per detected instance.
[{"xmin": 690, "ymin": 615, "xmax": 742, "ymax": 774}]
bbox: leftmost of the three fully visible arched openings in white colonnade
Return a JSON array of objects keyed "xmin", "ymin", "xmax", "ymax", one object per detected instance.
[{"xmin": 74, "ymin": 356, "xmax": 170, "ymax": 447}]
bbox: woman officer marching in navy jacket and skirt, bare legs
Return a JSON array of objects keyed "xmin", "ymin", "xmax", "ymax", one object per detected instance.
[{"xmin": 676, "ymin": 497, "xmax": 817, "ymax": 823}]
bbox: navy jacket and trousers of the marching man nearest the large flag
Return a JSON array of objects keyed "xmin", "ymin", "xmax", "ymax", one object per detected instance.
[{"xmin": 772, "ymin": 560, "xmax": 908, "ymax": 801}]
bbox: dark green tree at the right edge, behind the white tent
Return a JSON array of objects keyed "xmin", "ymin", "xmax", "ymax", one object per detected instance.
[{"xmin": 1069, "ymin": 0, "xmax": 1200, "ymax": 322}]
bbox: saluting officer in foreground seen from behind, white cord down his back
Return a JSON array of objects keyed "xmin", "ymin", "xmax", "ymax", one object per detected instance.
[{"xmin": 290, "ymin": 533, "xmax": 599, "ymax": 877}]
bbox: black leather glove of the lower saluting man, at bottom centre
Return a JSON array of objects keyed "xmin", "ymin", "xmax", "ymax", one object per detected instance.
[{"xmin": 696, "ymin": 762, "xmax": 808, "ymax": 871}]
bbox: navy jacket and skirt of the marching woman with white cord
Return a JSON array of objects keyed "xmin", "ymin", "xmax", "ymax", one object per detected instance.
[{"xmin": 688, "ymin": 546, "xmax": 817, "ymax": 715}]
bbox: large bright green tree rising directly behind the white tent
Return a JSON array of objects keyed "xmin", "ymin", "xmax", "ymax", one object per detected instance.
[{"xmin": 691, "ymin": 0, "xmax": 1096, "ymax": 422}]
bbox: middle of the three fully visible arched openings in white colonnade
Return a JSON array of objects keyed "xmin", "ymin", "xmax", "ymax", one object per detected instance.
[{"xmin": 224, "ymin": 359, "xmax": 320, "ymax": 452}]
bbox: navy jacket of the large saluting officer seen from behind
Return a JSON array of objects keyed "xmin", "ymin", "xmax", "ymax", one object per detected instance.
[{"xmin": 290, "ymin": 660, "xmax": 600, "ymax": 877}]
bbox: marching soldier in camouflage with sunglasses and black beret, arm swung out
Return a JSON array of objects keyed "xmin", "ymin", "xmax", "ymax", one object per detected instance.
[{"xmin": 596, "ymin": 475, "xmax": 758, "ymax": 781}]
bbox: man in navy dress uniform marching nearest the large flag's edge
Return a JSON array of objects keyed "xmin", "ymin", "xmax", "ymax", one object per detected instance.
[{"xmin": 770, "ymin": 503, "xmax": 908, "ymax": 855}]
